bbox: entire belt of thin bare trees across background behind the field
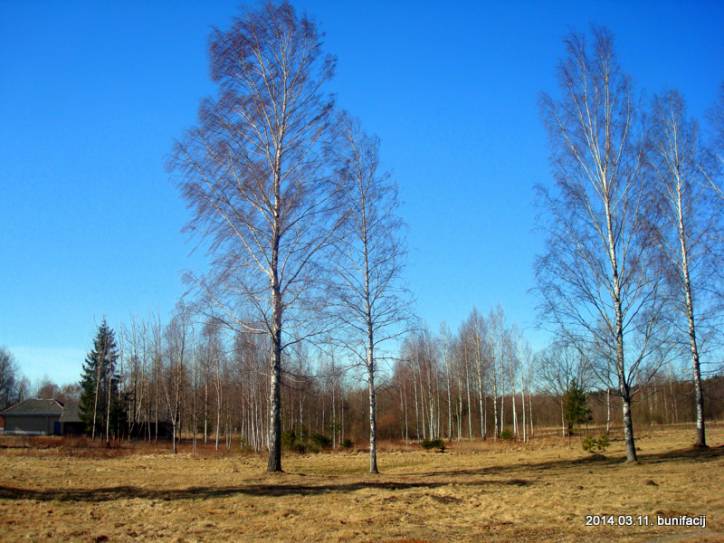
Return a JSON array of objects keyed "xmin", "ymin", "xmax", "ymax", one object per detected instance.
[{"xmin": 93, "ymin": 307, "xmax": 724, "ymax": 452}]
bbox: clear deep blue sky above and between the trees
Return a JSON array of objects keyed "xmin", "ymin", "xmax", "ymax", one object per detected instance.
[{"xmin": 0, "ymin": 0, "xmax": 724, "ymax": 382}]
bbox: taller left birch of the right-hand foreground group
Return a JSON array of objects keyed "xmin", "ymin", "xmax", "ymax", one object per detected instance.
[{"xmin": 536, "ymin": 29, "xmax": 662, "ymax": 461}]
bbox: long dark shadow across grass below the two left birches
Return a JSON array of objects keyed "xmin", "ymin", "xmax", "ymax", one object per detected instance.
[{"xmin": 0, "ymin": 479, "xmax": 532, "ymax": 502}]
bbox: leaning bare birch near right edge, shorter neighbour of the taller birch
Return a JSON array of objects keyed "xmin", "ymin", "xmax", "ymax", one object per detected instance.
[{"xmin": 648, "ymin": 92, "xmax": 724, "ymax": 447}]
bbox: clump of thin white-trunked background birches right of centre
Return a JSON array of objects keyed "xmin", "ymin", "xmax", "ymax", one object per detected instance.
[{"xmin": 393, "ymin": 307, "xmax": 536, "ymax": 441}]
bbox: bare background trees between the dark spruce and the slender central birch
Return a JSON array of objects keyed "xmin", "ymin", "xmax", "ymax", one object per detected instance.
[{"xmin": 108, "ymin": 305, "xmax": 374, "ymax": 452}]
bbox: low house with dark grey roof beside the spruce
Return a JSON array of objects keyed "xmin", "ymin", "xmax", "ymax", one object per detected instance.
[{"xmin": 0, "ymin": 398, "xmax": 83, "ymax": 435}]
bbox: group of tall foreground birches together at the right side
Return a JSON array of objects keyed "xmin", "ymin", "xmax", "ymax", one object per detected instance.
[{"xmin": 536, "ymin": 29, "xmax": 724, "ymax": 461}]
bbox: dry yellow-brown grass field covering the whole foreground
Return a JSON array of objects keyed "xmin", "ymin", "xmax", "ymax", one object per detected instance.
[{"xmin": 0, "ymin": 425, "xmax": 724, "ymax": 542}]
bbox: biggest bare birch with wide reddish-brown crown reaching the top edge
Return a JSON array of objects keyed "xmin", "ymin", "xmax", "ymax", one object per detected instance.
[{"xmin": 172, "ymin": 2, "xmax": 337, "ymax": 472}]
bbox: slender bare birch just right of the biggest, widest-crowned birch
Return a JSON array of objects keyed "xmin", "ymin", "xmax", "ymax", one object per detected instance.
[{"xmin": 332, "ymin": 115, "xmax": 410, "ymax": 473}]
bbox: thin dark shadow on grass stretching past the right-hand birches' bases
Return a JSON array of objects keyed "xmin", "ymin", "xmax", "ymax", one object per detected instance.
[{"xmin": 409, "ymin": 446, "xmax": 724, "ymax": 477}]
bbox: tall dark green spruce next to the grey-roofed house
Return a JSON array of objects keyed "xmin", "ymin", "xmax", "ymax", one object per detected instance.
[{"xmin": 79, "ymin": 319, "xmax": 122, "ymax": 441}]
